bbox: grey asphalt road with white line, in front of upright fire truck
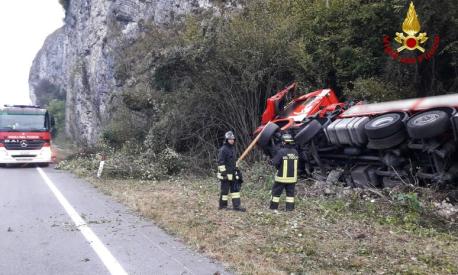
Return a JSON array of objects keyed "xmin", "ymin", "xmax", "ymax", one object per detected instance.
[{"xmin": 0, "ymin": 167, "xmax": 227, "ymax": 275}]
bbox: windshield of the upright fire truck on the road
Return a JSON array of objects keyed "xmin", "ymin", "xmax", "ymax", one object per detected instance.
[{"xmin": 0, "ymin": 112, "xmax": 48, "ymax": 132}]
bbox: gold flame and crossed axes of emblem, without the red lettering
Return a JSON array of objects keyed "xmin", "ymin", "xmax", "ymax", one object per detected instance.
[{"xmin": 394, "ymin": 2, "xmax": 428, "ymax": 53}]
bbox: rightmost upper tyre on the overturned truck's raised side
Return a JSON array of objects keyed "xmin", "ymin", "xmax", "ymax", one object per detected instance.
[{"xmin": 407, "ymin": 110, "xmax": 450, "ymax": 138}]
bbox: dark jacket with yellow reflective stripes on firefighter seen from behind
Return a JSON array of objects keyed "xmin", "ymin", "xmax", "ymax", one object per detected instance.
[{"xmin": 272, "ymin": 146, "xmax": 299, "ymax": 183}]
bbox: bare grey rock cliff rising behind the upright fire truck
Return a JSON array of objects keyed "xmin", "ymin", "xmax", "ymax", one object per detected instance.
[{"xmin": 29, "ymin": 0, "xmax": 237, "ymax": 144}]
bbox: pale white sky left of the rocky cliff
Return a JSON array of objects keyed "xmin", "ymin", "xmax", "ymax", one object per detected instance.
[{"xmin": 0, "ymin": 0, "xmax": 64, "ymax": 106}]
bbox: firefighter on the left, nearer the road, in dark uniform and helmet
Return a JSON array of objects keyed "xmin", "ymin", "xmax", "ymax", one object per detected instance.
[{"xmin": 218, "ymin": 131, "xmax": 246, "ymax": 212}]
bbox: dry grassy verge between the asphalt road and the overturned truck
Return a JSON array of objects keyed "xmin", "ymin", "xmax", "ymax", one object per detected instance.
[{"xmin": 88, "ymin": 179, "xmax": 458, "ymax": 274}]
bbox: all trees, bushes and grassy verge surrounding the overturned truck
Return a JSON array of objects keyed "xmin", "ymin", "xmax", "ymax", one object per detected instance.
[{"xmin": 53, "ymin": 0, "xmax": 458, "ymax": 274}]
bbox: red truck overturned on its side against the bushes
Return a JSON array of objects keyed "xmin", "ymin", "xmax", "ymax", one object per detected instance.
[{"xmin": 255, "ymin": 84, "xmax": 458, "ymax": 188}]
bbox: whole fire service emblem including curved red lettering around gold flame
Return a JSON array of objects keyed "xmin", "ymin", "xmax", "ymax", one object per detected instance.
[{"xmin": 383, "ymin": 2, "xmax": 440, "ymax": 64}]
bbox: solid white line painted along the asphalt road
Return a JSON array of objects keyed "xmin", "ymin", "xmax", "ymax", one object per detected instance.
[{"xmin": 37, "ymin": 167, "xmax": 127, "ymax": 275}]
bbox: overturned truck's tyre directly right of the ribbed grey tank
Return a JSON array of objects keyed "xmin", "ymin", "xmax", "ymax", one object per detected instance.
[{"xmin": 364, "ymin": 113, "xmax": 404, "ymax": 139}]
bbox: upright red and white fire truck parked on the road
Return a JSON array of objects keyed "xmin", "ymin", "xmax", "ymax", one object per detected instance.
[{"xmin": 0, "ymin": 105, "xmax": 54, "ymax": 166}]
